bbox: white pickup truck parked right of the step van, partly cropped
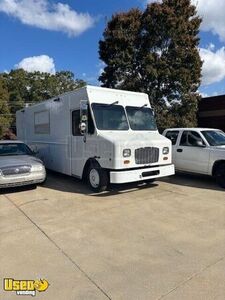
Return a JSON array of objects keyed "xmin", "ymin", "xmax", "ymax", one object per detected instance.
[{"xmin": 163, "ymin": 128, "xmax": 225, "ymax": 188}]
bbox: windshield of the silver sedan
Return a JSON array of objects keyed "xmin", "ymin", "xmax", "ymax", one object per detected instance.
[{"xmin": 0, "ymin": 143, "xmax": 33, "ymax": 156}]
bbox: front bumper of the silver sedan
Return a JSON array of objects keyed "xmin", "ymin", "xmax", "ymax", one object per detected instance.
[{"xmin": 0, "ymin": 170, "xmax": 46, "ymax": 188}]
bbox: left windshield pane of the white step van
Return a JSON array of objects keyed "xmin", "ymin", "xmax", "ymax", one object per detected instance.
[{"xmin": 92, "ymin": 103, "xmax": 129, "ymax": 130}]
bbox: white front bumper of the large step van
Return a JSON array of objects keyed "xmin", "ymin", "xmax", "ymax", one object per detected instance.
[{"xmin": 110, "ymin": 164, "xmax": 175, "ymax": 183}]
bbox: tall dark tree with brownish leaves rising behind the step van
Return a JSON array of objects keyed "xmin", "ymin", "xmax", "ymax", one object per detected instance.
[{"xmin": 99, "ymin": 0, "xmax": 202, "ymax": 130}]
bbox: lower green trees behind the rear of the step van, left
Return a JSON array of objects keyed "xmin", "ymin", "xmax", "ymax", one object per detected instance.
[{"xmin": 0, "ymin": 69, "xmax": 86, "ymax": 137}]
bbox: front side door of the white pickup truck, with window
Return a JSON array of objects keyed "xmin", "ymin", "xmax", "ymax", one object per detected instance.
[{"xmin": 174, "ymin": 130, "xmax": 210, "ymax": 174}]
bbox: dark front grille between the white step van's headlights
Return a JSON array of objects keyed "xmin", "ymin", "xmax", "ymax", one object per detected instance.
[{"xmin": 135, "ymin": 147, "xmax": 159, "ymax": 165}]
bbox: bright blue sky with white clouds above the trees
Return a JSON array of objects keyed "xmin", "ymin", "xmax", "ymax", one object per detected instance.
[{"xmin": 0, "ymin": 0, "xmax": 225, "ymax": 96}]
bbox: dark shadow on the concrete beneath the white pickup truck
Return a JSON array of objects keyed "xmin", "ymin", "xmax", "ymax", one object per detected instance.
[{"xmin": 160, "ymin": 172, "xmax": 225, "ymax": 191}]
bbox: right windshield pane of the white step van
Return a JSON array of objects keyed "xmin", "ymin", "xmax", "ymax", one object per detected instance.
[{"xmin": 126, "ymin": 106, "xmax": 157, "ymax": 130}]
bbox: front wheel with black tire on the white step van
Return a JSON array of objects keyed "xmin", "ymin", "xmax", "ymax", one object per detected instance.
[{"xmin": 86, "ymin": 162, "xmax": 109, "ymax": 193}]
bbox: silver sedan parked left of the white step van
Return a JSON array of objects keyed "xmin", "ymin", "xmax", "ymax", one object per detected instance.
[{"xmin": 0, "ymin": 141, "xmax": 46, "ymax": 188}]
